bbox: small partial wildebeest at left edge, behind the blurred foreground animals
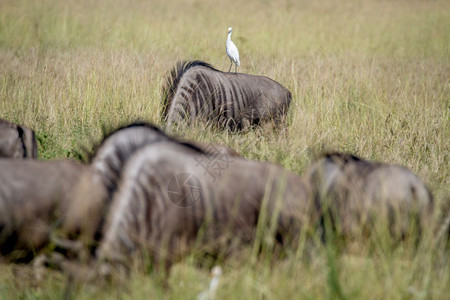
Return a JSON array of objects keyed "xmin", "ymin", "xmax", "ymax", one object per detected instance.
[{"xmin": 0, "ymin": 119, "xmax": 37, "ymax": 158}]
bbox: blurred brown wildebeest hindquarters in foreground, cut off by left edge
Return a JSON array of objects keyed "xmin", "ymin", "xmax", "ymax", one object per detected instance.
[{"xmin": 0, "ymin": 159, "xmax": 87, "ymax": 261}]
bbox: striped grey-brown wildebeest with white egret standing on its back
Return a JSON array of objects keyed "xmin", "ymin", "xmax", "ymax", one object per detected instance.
[{"xmin": 162, "ymin": 61, "xmax": 291, "ymax": 130}]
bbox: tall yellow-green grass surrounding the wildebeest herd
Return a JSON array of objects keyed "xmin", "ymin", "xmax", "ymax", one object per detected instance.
[{"xmin": 0, "ymin": 0, "xmax": 450, "ymax": 299}]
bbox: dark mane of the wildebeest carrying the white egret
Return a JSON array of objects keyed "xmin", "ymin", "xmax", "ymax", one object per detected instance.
[{"xmin": 161, "ymin": 60, "xmax": 221, "ymax": 120}]
